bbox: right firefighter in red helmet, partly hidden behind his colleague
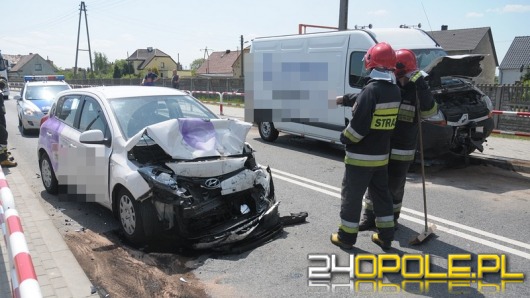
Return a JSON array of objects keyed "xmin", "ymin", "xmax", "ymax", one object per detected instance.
[{"xmin": 359, "ymin": 49, "xmax": 438, "ymax": 231}]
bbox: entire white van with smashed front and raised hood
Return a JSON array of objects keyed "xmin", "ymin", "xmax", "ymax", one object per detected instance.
[{"xmin": 245, "ymin": 28, "xmax": 493, "ymax": 157}]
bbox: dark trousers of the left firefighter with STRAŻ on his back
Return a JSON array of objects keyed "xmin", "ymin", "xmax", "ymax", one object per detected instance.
[{"xmin": 339, "ymin": 164, "xmax": 394, "ymax": 244}]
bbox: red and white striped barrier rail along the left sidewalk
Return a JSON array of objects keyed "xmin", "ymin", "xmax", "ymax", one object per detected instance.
[{"xmin": 0, "ymin": 167, "xmax": 42, "ymax": 298}]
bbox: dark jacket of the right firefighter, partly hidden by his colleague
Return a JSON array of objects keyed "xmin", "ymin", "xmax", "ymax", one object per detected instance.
[{"xmin": 390, "ymin": 72, "xmax": 438, "ymax": 162}]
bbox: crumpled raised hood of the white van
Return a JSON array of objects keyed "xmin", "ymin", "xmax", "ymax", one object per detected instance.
[{"xmin": 424, "ymin": 54, "xmax": 486, "ymax": 87}]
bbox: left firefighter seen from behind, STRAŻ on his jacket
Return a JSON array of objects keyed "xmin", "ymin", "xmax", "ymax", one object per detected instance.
[{"xmin": 330, "ymin": 42, "xmax": 401, "ymax": 249}]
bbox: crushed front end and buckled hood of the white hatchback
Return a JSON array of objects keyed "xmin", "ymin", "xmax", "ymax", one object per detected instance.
[{"xmin": 126, "ymin": 118, "xmax": 282, "ymax": 249}]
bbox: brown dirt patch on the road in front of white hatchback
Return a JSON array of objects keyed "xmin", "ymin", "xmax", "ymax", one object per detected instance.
[{"xmin": 64, "ymin": 229, "xmax": 207, "ymax": 297}]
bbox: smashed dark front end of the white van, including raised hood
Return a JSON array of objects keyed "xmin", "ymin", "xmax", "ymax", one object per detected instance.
[{"xmin": 422, "ymin": 55, "xmax": 494, "ymax": 159}]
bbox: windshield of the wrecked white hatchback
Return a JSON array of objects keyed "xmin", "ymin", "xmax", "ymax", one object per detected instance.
[{"xmin": 109, "ymin": 95, "xmax": 218, "ymax": 139}]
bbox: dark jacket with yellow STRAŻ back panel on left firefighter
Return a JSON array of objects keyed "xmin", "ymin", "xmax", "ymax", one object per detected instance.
[{"xmin": 340, "ymin": 79, "xmax": 401, "ymax": 167}]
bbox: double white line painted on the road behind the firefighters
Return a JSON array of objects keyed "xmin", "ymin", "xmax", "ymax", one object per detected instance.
[{"xmin": 272, "ymin": 169, "xmax": 530, "ymax": 259}]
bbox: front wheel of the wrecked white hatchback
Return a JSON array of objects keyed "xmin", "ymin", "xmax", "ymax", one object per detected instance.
[{"xmin": 117, "ymin": 189, "xmax": 158, "ymax": 244}]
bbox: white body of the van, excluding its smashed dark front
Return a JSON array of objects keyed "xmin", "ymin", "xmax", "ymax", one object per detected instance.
[{"xmin": 245, "ymin": 28, "xmax": 447, "ymax": 143}]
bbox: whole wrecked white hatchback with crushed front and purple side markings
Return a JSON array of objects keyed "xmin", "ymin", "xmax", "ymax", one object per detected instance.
[{"xmin": 38, "ymin": 86, "xmax": 281, "ymax": 249}]
